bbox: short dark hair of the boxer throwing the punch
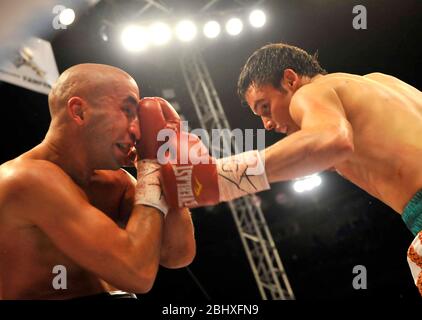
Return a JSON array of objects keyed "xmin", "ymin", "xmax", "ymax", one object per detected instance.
[{"xmin": 237, "ymin": 43, "xmax": 327, "ymax": 103}]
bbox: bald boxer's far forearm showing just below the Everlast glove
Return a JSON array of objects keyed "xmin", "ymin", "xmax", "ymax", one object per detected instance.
[{"xmin": 160, "ymin": 209, "xmax": 196, "ymax": 268}]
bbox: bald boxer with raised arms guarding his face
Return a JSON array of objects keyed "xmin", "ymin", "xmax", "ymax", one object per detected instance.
[{"xmin": 0, "ymin": 64, "xmax": 195, "ymax": 299}]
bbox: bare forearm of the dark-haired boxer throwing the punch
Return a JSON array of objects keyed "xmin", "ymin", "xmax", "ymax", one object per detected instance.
[{"xmin": 261, "ymin": 129, "xmax": 353, "ymax": 183}]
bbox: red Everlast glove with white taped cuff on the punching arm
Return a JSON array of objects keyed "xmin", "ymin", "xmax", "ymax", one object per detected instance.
[{"xmin": 158, "ymin": 122, "xmax": 269, "ymax": 208}]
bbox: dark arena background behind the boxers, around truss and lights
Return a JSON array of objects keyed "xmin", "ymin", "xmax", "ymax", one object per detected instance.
[{"xmin": 0, "ymin": 0, "xmax": 422, "ymax": 301}]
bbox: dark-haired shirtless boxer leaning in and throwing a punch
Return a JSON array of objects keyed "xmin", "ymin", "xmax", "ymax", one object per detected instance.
[{"xmin": 152, "ymin": 43, "xmax": 422, "ymax": 293}]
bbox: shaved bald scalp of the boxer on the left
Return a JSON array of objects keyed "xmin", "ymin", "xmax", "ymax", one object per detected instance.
[{"xmin": 48, "ymin": 63, "xmax": 136, "ymax": 118}]
